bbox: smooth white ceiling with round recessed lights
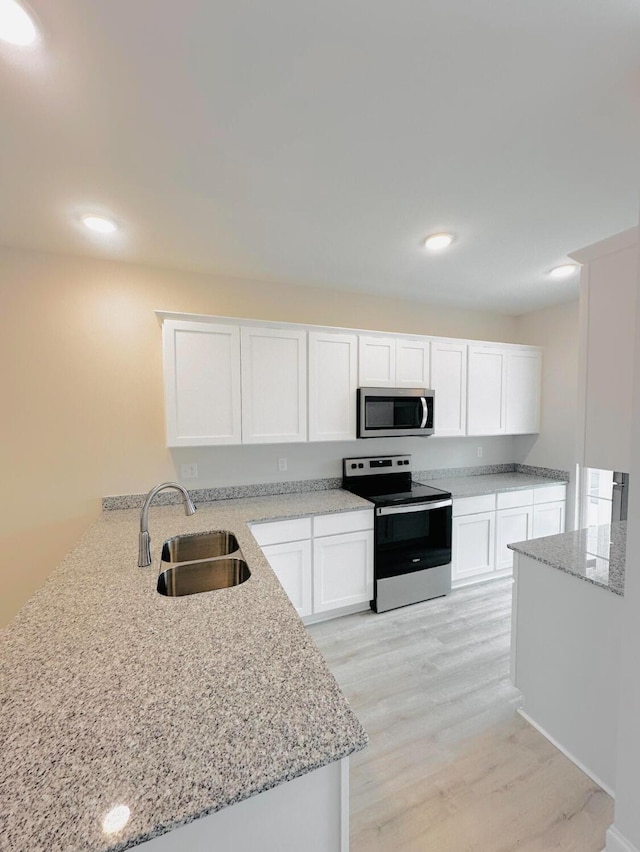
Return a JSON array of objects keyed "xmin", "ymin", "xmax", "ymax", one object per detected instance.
[{"xmin": 0, "ymin": 0, "xmax": 640, "ymax": 313}]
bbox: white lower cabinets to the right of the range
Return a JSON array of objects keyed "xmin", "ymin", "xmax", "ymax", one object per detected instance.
[{"xmin": 451, "ymin": 485, "xmax": 566, "ymax": 585}]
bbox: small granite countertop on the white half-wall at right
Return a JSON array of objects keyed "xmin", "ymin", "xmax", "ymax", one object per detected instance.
[{"xmin": 507, "ymin": 521, "xmax": 627, "ymax": 595}]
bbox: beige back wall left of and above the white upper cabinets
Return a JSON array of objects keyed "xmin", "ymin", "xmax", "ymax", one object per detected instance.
[{"xmin": 0, "ymin": 243, "xmax": 517, "ymax": 623}]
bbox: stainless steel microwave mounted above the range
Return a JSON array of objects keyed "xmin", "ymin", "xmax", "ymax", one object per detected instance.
[{"xmin": 358, "ymin": 388, "xmax": 434, "ymax": 438}]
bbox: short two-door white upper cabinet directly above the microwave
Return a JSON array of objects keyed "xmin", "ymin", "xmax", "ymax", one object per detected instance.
[{"xmin": 358, "ymin": 334, "xmax": 430, "ymax": 388}]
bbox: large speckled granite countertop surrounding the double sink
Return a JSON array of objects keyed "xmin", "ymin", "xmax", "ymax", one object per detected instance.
[{"xmin": 0, "ymin": 490, "xmax": 371, "ymax": 852}]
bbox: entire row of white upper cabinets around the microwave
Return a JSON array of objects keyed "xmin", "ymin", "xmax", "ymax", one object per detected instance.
[{"xmin": 159, "ymin": 312, "xmax": 544, "ymax": 446}]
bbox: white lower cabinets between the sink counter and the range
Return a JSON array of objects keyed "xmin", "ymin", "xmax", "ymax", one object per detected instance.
[{"xmin": 251, "ymin": 509, "xmax": 373, "ymax": 620}]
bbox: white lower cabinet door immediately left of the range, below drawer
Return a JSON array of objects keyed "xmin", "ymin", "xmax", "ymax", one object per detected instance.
[{"xmin": 313, "ymin": 530, "xmax": 373, "ymax": 612}]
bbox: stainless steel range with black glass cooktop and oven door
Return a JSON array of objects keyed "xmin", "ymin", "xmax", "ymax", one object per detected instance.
[{"xmin": 342, "ymin": 455, "xmax": 453, "ymax": 612}]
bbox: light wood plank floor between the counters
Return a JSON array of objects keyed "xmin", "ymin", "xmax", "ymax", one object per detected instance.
[{"xmin": 309, "ymin": 580, "xmax": 613, "ymax": 852}]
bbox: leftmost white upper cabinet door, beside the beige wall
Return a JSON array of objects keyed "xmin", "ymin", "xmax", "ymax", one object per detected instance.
[{"xmin": 162, "ymin": 320, "xmax": 241, "ymax": 447}]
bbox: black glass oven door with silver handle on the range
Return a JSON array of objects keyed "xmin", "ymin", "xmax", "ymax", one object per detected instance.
[{"xmin": 374, "ymin": 499, "xmax": 452, "ymax": 580}]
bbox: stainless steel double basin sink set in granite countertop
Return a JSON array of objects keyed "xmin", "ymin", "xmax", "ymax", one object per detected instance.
[{"xmin": 157, "ymin": 530, "xmax": 251, "ymax": 597}]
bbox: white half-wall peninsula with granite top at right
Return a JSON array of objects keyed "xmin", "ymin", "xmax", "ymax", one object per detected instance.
[{"xmin": 509, "ymin": 522, "xmax": 626, "ymax": 795}]
